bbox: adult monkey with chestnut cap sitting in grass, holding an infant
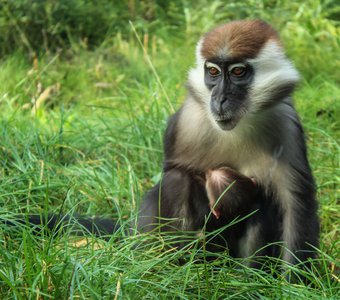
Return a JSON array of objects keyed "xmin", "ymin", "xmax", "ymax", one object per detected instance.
[{"xmin": 139, "ymin": 20, "xmax": 319, "ymax": 274}]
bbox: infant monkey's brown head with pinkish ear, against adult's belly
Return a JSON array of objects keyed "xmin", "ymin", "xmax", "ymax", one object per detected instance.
[{"xmin": 205, "ymin": 167, "xmax": 257, "ymax": 219}]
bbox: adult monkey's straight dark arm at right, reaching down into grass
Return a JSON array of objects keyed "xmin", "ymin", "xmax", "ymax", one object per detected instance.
[{"xmin": 276, "ymin": 118, "xmax": 320, "ymax": 264}]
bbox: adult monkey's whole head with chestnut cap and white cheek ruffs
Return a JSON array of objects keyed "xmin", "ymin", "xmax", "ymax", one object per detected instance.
[{"xmin": 189, "ymin": 20, "xmax": 299, "ymax": 130}]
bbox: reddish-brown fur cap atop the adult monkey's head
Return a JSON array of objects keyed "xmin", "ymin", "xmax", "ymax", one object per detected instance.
[{"xmin": 201, "ymin": 20, "xmax": 279, "ymax": 59}]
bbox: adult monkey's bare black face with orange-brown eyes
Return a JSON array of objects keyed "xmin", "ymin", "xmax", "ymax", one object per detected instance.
[{"xmin": 204, "ymin": 58, "xmax": 254, "ymax": 130}]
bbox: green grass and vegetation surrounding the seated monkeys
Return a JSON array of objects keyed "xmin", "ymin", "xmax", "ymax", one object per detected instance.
[{"xmin": 0, "ymin": 0, "xmax": 340, "ymax": 299}]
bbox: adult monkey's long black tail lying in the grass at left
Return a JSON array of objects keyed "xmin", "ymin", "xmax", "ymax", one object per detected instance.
[{"xmin": 1, "ymin": 214, "xmax": 120, "ymax": 237}]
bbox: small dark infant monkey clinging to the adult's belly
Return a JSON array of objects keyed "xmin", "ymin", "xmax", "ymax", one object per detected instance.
[{"xmin": 204, "ymin": 167, "xmax": 258, "ymax": 257}]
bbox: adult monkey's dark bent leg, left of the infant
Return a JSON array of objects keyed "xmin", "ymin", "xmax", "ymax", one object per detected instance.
[{"xmin": 138, "ymin": 168, "xmax": 209, "ymax": 231}]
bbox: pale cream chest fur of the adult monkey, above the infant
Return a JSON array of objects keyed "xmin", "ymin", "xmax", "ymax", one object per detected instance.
[{"xmin": 175, "ymin": 101, "xmax": 277, "ymax": 180}]
